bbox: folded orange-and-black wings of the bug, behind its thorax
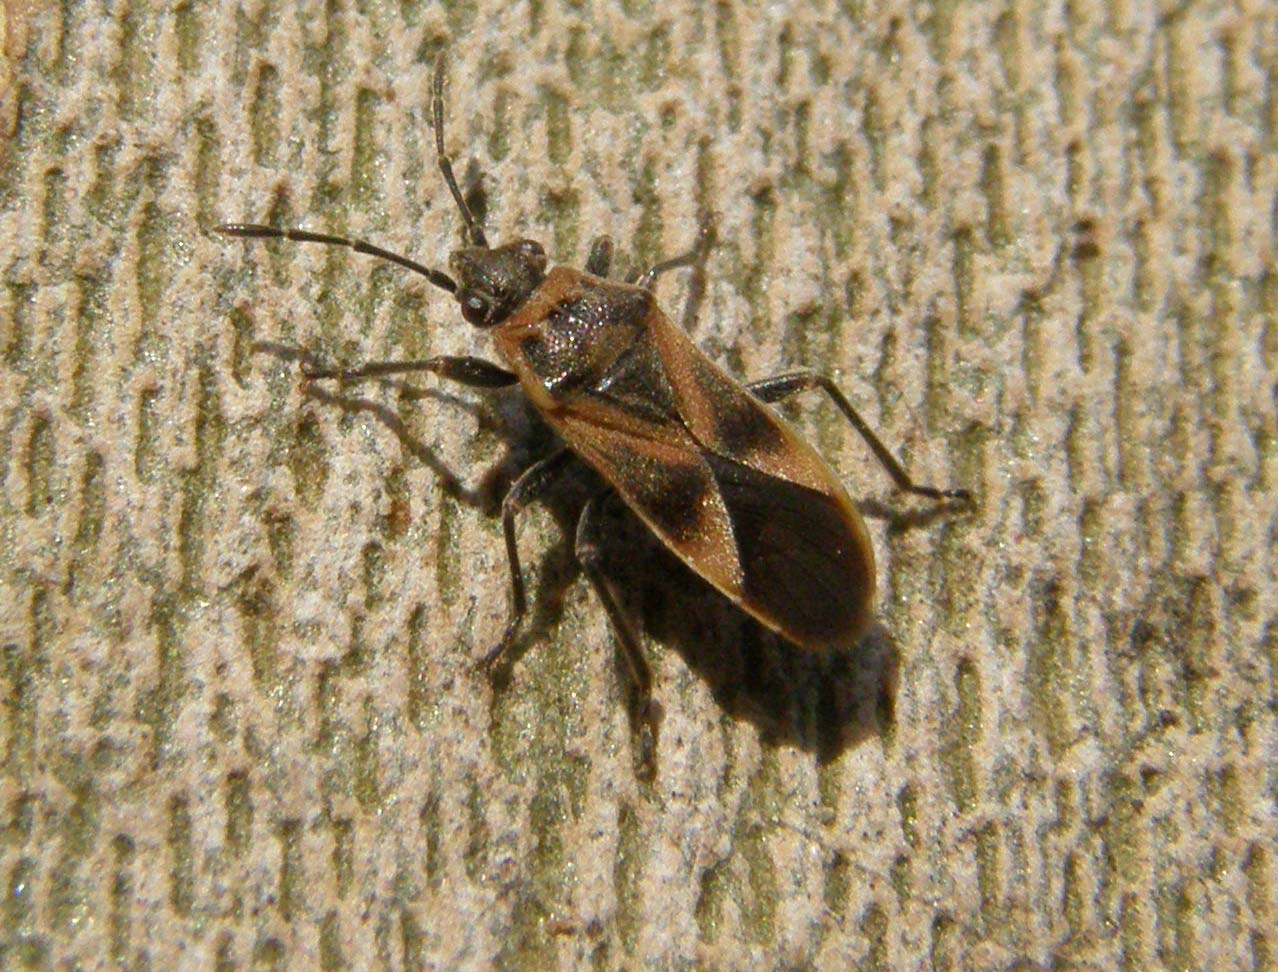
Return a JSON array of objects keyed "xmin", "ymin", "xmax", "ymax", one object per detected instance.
[{"xmin": 547, "ymin": 324, "xmax": 874, "ymax": 649}]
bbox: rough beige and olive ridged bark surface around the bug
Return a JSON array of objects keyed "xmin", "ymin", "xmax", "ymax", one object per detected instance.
[{"xmin": 0, "ymin": 0, "xmax": 1278, "ymax": 969}]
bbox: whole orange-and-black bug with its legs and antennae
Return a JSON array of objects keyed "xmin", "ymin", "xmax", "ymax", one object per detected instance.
[{"xmin": 217, "ymin": 56, "xmax": 970, "ymax": 773}]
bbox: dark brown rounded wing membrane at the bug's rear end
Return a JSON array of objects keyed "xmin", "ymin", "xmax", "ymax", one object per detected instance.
[{"xmin": 705, "ymin": 453, "xmax": 874, "ymax": 648}]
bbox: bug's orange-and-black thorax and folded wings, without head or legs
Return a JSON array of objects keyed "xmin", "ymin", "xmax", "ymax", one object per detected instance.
[{"xmin": 496, "ymin": 268, "xmax": 874, "ymax": 649}]
